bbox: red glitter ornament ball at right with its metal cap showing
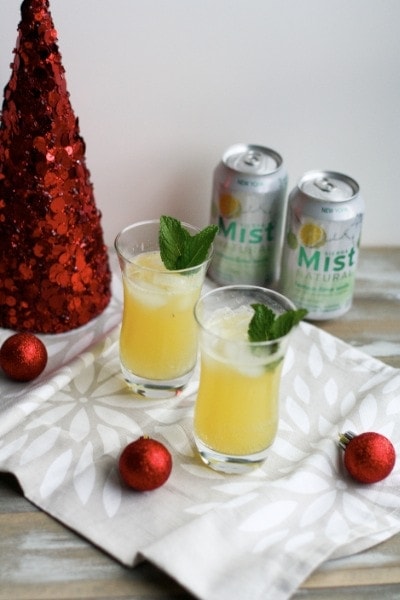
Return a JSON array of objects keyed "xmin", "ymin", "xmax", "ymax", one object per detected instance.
[{"xmin": 340, "ymin": 431, "xmax": 396, "ymax": 483}]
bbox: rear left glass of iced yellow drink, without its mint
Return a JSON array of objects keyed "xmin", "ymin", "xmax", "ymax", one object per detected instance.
[{"xmin": 115, "ymin": 220, "xmax": 209, "ymax": 398}]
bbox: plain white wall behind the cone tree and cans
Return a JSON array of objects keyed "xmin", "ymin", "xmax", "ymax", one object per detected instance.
[{"xmin": 0, "ymin": 0, "xmax": 400, "ymax": 246}]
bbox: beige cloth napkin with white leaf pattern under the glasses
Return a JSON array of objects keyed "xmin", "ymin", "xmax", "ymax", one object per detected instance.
[{"xmin": 0, "ymin": 258, "xmax": 400, "ymax": 600}]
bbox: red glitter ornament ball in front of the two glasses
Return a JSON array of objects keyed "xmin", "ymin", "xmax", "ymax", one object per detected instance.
[{"xmin": 118, "ymin": 437, "xmax": 172, "ymax": 492}]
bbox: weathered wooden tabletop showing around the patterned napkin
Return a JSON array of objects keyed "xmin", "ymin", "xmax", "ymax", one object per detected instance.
[{"xmin": 0, "ymin": 247, "xmax": 400, "ymax": 600}]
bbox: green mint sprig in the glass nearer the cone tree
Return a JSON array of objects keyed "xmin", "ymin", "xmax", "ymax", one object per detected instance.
[{"xmin": 159, "ymin": 215, "xmax": 218, "ymax": 271}]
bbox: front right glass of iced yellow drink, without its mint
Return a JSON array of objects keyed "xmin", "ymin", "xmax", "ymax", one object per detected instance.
[{"xmin": 194, "ymin": 285, "xmax": 294, "ymax": 473}]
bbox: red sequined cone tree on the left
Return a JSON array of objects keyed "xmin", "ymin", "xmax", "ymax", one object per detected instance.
[{"xmin": 0, "ymin": 0, "xmax": 111, "ymax": 333}]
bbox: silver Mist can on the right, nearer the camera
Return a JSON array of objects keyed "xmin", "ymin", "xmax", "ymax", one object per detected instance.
[{"xmin": 279, "ymin": 171, "xmax": 364, "ymax": 320}]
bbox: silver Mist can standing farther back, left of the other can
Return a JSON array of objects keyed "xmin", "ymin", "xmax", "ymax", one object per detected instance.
[{"xmin": 209, "ymin": 144, "xmax": 287, "ymax": 285}]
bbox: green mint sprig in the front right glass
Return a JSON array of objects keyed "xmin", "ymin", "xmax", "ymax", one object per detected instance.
[{"xmin": 247, "ymin": 304, "xmax": 308, "ymax": 342}]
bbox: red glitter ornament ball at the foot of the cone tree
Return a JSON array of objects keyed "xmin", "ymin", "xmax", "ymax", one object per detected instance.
[{"xmin": 0, "ymin": 333, "xmax": 47, "ymax": 381}]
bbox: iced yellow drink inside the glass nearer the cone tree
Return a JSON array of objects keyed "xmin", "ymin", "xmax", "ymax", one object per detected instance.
[{"xmin": 120, "ymin": 251, "xmax": 203, "ymax": 380}]
